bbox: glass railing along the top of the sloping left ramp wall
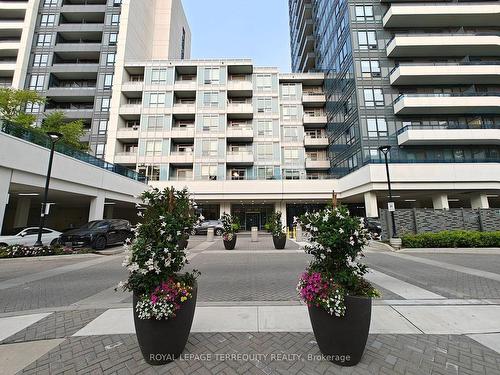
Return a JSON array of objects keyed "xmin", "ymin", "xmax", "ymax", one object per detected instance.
[{"xmin": 0, "ymin": 122, "xmax": 147, "ymax": 183}]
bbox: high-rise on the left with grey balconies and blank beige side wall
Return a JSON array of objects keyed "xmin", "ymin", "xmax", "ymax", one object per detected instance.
[{"xmin": 0, "ymin": 0, "xmax": 191, "ymax": 157}]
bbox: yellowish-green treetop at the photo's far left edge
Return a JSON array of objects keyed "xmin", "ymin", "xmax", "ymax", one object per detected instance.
[{"xmin": 0, "ymin": 88, "xmax": 45, "ymax": 127}]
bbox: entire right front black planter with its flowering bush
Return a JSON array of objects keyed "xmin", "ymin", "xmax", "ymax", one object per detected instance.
[{"xmin": 297, "ymin": 207, "xmax": 378, "ymax": 366}]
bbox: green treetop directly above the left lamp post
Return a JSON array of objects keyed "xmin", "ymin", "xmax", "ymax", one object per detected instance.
[{"xmin": 40, "ymin": 112, "xmax": 89, "ymax": 151}]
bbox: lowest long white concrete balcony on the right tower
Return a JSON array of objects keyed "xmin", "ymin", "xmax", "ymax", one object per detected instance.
[{"xmin": 398, "ymin": 125, "xmax": 500, "ymax": 146}]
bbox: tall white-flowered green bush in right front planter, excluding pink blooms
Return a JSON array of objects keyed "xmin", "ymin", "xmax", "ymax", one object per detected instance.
[{"xmin": 298, "ymin": 206, "xmax": 378, "ymax": 297}]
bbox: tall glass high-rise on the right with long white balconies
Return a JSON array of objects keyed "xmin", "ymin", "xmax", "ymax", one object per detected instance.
[{"xmin": 289, "ymin": 0, "xmax": 500, "ymax": 215}]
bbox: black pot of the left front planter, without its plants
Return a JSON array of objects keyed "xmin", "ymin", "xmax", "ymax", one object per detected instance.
[{"xmin": 133, "ymin": 284, "xmax": 198, "ymax": 366}]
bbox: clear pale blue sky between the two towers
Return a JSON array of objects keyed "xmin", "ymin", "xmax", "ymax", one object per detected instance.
[{"xmin": 182, "ymin": 0, "xmax": 291, "ymax": 73}]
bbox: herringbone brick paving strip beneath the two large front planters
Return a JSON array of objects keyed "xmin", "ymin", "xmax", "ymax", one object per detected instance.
[{"xmin": 17, "ymin": 333, "xmax": 500, "ymax": 374}]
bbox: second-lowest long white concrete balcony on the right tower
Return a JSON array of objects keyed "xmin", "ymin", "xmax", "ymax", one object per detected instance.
[{"xmin": 394, "ymin": 93, "xmax": 500, "ymax": 115}]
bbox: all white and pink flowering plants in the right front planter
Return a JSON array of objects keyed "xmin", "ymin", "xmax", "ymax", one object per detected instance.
[{"xmin": 296, "ymin": 206, "xmax": 378, "ymax": 316}]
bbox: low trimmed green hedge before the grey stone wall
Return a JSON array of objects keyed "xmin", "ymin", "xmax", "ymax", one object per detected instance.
[{"xmin": 402, "ymin": 230, "xmax": 500, "ymax": 248}]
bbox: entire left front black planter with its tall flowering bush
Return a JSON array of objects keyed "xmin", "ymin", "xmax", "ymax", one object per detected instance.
[{"xmin": 120, "ymin": 188, "xmax": 199, "ymax": 365}]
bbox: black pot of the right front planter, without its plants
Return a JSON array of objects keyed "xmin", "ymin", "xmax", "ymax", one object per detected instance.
[{"xmin": 309, "ymin": 296, "xmax": 372, "ymax": 366}]
